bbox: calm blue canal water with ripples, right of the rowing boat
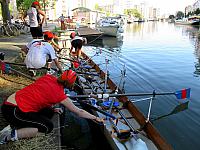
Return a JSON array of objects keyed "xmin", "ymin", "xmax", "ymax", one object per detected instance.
[{"xmin": 84, "ymin": 22, "xmax": 200, "ymax": 150}]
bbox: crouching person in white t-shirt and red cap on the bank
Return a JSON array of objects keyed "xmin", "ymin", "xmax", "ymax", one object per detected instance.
[{"xmin": 22, "ymin": 32, "xmax": 62, "ymax": 76}]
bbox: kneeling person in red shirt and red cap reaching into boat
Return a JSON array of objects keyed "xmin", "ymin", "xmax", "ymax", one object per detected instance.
[{"xmin": 0, "ymin": 70, "xmax": 103, "ymax": 144}]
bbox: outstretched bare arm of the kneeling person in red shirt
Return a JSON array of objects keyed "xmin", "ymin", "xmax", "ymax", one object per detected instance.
[{"xmin": 61, "ymin": 98, "xmax": 103, "ymax": 122}]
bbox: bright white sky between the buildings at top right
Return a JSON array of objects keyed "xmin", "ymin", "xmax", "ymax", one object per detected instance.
[{"xmin": 145, "ymin": 0, "xmax": 197, "ymax": 13}]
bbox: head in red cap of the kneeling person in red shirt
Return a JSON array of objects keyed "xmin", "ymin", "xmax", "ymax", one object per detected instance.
[{"xmin": 57, "ymin": 69, "xmax": 77, "ymax": 89}]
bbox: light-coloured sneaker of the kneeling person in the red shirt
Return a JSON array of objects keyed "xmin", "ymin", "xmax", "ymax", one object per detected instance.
[{"xmin": 0, "ymin": 125, "xmax": 12, "ymax": 144}]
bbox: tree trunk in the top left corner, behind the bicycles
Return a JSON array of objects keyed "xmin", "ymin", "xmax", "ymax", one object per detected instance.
[{"xmin": 0, "ymin": 0, "xmax": 10, "ymax": 23}]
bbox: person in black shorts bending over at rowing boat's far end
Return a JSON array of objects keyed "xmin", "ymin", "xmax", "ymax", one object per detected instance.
[{"xmin": 70, "ymin": 32, "xmax": 87, "ymax": 59}]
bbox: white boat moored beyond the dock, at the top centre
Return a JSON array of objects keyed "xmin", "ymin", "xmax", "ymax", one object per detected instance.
[{"xmin": 97, "ymin": 17, "xmax": 124, "ymax": 37}]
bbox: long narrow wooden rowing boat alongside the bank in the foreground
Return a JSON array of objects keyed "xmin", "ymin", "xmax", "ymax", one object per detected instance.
[{"xmin": 68, "ymin": 53, "xmax": 172, "ymax": 150}]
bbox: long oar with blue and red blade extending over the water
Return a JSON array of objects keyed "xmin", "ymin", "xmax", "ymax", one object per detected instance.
[{"xmin": 69, "ymin": 88, "xmax": 191, "ymax": 99}]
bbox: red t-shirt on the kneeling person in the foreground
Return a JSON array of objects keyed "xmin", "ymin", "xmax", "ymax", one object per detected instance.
[{"xmin": 15, "ymin": 75, "xmax": 67, "ymax": 112}]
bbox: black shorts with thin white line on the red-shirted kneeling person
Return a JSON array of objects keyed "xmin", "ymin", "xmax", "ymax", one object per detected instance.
[{"xmin": 1, "ymin": 104, "xmax": 54, "ymax": 133}]
